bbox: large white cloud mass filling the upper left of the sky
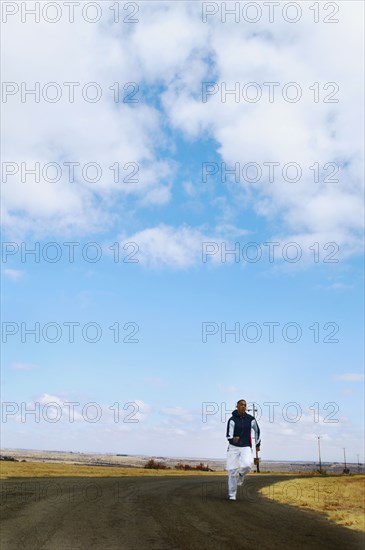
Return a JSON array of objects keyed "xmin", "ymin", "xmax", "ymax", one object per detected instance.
[{"xmin": 2, "ymin": 10, "xmax": 171, "ymax": 235}]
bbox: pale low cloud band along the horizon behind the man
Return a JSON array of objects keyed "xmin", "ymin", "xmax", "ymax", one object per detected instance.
[{"xmin": 4, "ymin": 393, "xmax": 361, "ymax": 461}]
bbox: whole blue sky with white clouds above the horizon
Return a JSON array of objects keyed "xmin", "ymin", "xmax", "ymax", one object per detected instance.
[{"xmin": 1, "ymin": 1, "xmax": 365, "ymax": 462}]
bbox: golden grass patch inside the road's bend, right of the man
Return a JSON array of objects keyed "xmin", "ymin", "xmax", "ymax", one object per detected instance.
[{"xmin": 260, "ymin": 475, "xmax": 365, "ymax": 531}]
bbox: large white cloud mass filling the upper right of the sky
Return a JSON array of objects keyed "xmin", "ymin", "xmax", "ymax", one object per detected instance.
[{"xmin": 163, "ymin": 3, "xmax": 364, "ymax": 253}]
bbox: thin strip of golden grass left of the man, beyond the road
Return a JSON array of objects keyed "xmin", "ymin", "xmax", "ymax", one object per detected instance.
[{"xmin": 0, "ymin": 461, "xmax": 223, "ymax": 479}]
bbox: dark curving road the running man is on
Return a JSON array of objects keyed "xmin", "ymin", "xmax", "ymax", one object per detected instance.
[{"xmin": 0, "ymin": 476, "xmax": 364, "ymax": 550}]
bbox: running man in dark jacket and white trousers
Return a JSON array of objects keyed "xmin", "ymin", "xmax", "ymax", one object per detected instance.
[{"xmin": 226, "ymin": 399, "xmax": 261, "ymax": 500}]
